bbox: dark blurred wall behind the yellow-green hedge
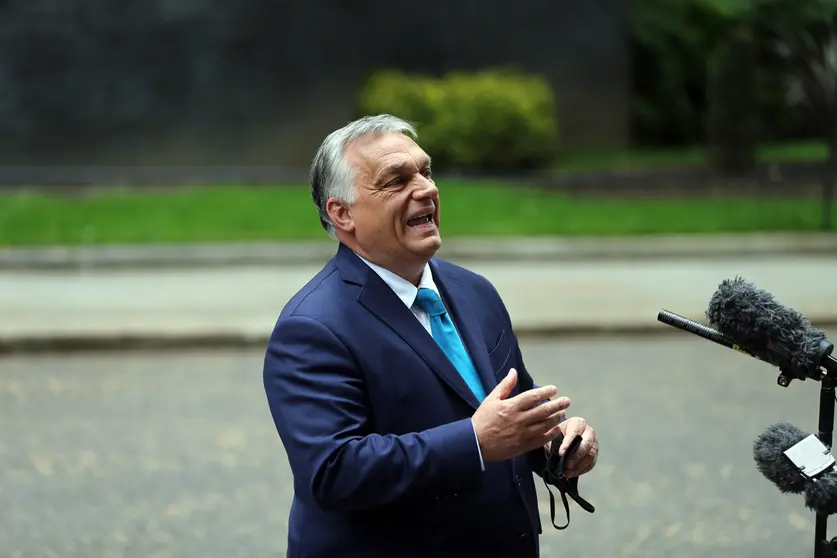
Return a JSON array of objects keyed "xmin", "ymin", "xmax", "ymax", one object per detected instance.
[{"xmin": 0, "ymin": 0, "xmax": 630, "ymax": 167}]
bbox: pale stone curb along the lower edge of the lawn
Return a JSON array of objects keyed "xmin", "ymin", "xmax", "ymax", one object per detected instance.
[{"xmin": 0, "ymin": 232, "xmax": 837, "ymax": 271}]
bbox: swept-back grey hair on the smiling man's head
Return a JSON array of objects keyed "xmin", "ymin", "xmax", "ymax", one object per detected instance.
[{"xmin": 309, "ymin": 114, "xmax": 418, "ymax": 240}]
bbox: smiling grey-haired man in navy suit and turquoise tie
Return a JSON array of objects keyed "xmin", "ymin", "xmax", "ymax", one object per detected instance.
[{"xmin": 264, "ymin": 115, "xmax": 598, "ymax": 558}]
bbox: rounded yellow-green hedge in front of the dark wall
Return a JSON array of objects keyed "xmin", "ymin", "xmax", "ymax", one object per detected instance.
[{"xmin": 359, "ymin": 70, "xmax": 558, "ymax": 172}]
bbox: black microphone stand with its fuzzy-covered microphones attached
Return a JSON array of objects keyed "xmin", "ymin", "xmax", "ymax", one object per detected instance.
[{"xmin": 657, "ymin": 277, "xmax": 837, "ymax": 558}]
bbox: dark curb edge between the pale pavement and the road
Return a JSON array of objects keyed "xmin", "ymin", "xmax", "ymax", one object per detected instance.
[{"xmin": 8, "ymin": 316, "xmax": 837, "ymax": 357}]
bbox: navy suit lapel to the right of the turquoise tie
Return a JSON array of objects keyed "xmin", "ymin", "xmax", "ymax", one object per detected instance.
[{"xmin": 430, "ymin": 261, "xmax": 497, "ymax": 393}]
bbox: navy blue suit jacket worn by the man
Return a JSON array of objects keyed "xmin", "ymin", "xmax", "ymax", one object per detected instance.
[{"xmin": 264, "ymin": 244, "xmax": 544, "ymax": 558}]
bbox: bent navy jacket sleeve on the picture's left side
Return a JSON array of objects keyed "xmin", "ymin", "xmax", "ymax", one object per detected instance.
[{"xmin": 263, "ymin": 316, "xmax": 482, "ymax": 511}]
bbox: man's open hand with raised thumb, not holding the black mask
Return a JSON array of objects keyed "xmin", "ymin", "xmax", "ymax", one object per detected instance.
[{"xmin": 472, "ymin": 368, "xmax": 570, "ymax": 461}]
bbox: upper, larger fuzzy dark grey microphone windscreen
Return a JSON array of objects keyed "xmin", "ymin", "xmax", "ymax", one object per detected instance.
[{"xmin": 706, "ymin": 277, "xmax": 826, "ymax": 371}]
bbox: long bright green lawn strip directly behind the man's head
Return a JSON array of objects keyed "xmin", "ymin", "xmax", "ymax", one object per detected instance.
[{"xmin": 0, "ymin": 181, "xmax": 837, "ymax": 246}]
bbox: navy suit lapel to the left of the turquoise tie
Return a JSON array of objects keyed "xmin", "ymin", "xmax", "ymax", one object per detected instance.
[{"xmin": 337, "ymin": 245, "xmax": 479, "ymax": 409}]
